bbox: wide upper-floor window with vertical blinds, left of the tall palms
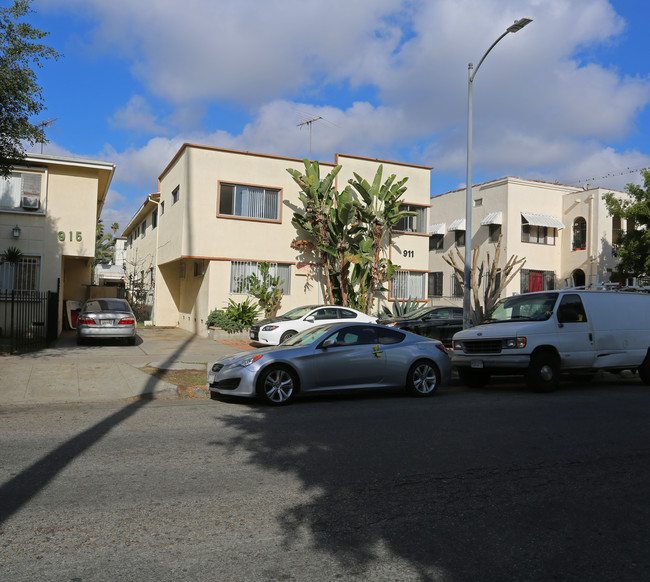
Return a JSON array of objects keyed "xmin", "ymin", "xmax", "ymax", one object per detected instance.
[{"xmin": 219, "ymin": 184, "xmax": 280, "ymax": 220}]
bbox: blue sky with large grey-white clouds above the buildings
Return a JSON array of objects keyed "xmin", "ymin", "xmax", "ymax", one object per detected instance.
[{"xmin": 19, "ymin": 0, "xmax": 650, "ymax": 230}]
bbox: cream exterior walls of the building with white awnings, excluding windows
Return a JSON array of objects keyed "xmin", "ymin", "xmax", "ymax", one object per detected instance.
[{"xmin": 429, "ymin": 177, "xmax": 626, "ymax": 305}]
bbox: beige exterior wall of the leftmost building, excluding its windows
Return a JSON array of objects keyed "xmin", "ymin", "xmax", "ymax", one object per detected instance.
[{"xmin": 0, "ymin": 154, "xmax": 115, "ymax": 332}]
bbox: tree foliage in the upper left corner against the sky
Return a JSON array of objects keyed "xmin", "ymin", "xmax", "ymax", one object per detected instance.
[{"xmin": 0, "ymin": 0, "xmax": 60, "ymax": 177}]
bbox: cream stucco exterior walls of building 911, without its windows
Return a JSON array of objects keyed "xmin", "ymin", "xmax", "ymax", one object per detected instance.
[{"xmin": 123, "ymin": 144, "xmax": 430, "ymax": 335}]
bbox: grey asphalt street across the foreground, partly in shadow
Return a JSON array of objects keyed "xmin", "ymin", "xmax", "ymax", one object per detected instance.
[{"xmin": 0, "ymin": 377, "xmax": 650, "ymax": 582}]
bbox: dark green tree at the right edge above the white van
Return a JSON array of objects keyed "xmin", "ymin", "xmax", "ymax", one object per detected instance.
[{"xmin": 605, "ymin": 170, "xmax": 650, "ymax": 278}]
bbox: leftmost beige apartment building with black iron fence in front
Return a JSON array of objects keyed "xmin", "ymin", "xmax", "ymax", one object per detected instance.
[{"xmin": 0, "ymin": 154, "xmax": 115, "ymax": 333}]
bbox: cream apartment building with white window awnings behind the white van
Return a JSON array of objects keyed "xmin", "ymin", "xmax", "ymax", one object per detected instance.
[{"xmin": 429, "ymin": 177, "xmax": 627, "ymax": 304}]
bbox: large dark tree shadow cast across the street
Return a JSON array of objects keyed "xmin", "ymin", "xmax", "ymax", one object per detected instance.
[{"xmin": 213, "ymin": 392, "xmax": 650, "ymax": 581}]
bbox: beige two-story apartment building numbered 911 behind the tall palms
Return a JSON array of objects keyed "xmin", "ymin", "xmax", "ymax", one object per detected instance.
[{"xmin": 122, "ymin": 144, "xmax": 431, "ymax": 335}]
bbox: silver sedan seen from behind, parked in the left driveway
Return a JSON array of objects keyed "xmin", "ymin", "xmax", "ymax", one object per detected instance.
[{"xmin": 77, "ymin": 298, "xmax": 135, "ymax": 346}]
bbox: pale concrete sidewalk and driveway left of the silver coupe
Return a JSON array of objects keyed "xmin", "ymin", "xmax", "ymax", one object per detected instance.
[{"xmin": 0, "ymin": 327, "xmax": 251, "ymax": 406}]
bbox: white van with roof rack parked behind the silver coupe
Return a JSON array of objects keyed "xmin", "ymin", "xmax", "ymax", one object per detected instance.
[{"xmin": 452, "ymin": 289, "xmax": 650, "ymax": 392}]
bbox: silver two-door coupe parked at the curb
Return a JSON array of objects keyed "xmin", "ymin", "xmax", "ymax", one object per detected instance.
[{"xmin": 208, "ymin": 323, "xmax": 451, "ymax": 404}]
